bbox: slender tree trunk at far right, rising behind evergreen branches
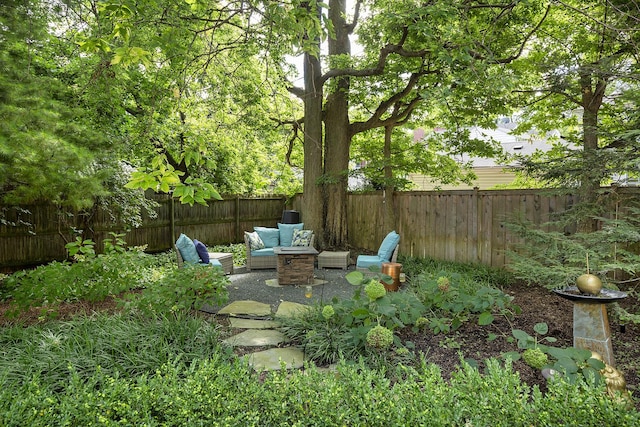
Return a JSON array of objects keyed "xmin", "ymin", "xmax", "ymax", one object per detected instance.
[{"xmin": 578, "ymin": 67, "xmax": 606, "ymax": 233}]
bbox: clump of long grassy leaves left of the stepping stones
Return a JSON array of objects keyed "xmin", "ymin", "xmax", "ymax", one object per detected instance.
[{"xmin": 0, "ymin": 314, "xmax": 230, "ymax": 391}]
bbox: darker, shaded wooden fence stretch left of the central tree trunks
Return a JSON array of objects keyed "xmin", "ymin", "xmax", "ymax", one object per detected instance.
[{"xmin": 0, "ymin": 195, "xmax": 287, "ymax": 268}]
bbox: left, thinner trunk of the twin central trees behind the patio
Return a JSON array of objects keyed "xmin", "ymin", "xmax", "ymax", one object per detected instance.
[{"xmin": 302, "ymin": 2, "xmax": 324, "ymax": 244}]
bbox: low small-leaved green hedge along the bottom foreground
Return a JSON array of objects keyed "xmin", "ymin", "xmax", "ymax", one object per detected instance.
[{"xmin": 0, "ymin": 356, "xmax": 640, "ymax": 427}]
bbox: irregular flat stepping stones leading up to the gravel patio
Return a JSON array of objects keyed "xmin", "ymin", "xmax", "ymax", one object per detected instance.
[{"xmin": 218, "ymin": 300, "xmax": 309, "ymax": 371}]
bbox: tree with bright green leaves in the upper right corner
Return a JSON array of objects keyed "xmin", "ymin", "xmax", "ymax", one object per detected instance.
[{"xmin": 507, "ymin": 1, "xmax": 640, "ymax": 196}]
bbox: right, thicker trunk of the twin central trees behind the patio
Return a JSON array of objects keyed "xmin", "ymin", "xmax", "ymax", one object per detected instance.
[{"xmin": 323, "ymin": 0, "xmax": 351, "ymax": 248}]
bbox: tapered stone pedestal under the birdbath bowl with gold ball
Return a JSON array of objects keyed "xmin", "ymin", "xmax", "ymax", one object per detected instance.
[{"xmin": 573, "ymin": 302, "xmax": 615, "ymax": 366}]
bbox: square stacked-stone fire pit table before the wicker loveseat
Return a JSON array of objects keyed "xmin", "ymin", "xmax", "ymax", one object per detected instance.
[{"xmin": 273, "ymin": 246, "xmax": 318, "ymax": 285}]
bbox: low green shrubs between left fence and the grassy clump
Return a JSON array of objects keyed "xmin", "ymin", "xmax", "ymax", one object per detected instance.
[{"xmin": 0, "ymin": 246, "xmax": 229, "ymax": 317}]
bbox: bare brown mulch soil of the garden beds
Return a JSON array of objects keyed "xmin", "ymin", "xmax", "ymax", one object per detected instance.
[{"xmin": 0, "ymin": 284, "xmax": 640, "ymax": 410}]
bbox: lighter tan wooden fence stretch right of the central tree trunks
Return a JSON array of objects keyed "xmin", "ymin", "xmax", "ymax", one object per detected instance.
[{"xmin": 347, "ymin": 188, "xmax": 640, "ymax": 267}]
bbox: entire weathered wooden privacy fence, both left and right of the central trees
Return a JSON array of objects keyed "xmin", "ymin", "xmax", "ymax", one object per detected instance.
[{"xmin": 0, "ymin": 188, "xmax": 640, "ymax": 268}]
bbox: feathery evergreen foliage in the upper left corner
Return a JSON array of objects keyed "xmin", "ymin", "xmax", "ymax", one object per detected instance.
[{"xmin": 0, "ymin": 1, "xmax": 108, "ymax": 208}]
